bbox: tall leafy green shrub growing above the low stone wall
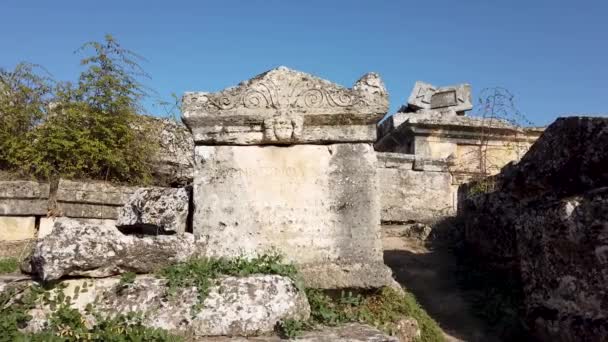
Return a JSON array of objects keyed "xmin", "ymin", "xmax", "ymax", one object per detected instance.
[{"xmin": 0, "ymin": 36, "xmax": 158, "ymax": 184}]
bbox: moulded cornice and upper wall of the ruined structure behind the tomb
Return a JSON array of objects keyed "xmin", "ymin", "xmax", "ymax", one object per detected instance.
[{"xmin": 374, "ymin": 112, "xmax": 542, "ymax": 175}]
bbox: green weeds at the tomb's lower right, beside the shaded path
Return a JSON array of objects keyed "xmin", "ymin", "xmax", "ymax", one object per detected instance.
[{"xmin": 306, "ymin": 287, "xmax": 444, "ymax": 342}]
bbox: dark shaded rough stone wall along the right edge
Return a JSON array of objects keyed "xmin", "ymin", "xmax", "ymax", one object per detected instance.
[{"xmin": 460, "ymin": 117, "xmax": 608, "ymax": 341}]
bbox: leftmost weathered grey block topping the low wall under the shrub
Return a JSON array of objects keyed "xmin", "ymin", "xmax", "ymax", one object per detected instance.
[{"xmin": 0, "ymin": 181, "xmax": 49, "ymax": 216}]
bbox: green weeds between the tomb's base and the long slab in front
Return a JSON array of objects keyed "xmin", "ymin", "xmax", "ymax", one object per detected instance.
[{"xmin": 158, "ymin": 253, "xmax": 300, "ymax": 312}]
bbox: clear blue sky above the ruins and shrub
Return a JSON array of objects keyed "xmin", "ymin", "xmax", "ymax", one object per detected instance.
[{"xmin": 0, "ymin": 0, "xmax": 608, "ymax": 125}]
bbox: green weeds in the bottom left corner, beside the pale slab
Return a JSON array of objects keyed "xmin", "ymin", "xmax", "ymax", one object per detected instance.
[{"xmin": 0, "ymin": 286, "xmax": 182, "ymax": 342}]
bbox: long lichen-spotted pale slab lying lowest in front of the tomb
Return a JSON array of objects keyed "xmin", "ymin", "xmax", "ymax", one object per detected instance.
[{"xmin": 27, "ymin": 275, "xmax": 310, "ymax": 338}]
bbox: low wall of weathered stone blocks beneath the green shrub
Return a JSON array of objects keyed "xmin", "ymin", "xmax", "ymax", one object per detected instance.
[{"xmin": 0, "ymin": 179, "xmax": 137, "ymax": 257}]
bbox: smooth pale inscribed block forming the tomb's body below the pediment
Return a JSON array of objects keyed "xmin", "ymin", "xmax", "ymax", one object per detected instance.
[{"xmin": 193, "ymin": 144, "xmax": 390, "ymax": 287}]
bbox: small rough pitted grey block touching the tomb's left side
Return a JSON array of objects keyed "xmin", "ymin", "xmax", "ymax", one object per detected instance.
[{"xmin": 116, "ymin": 188, "xmax": 190, "ymax": 234}]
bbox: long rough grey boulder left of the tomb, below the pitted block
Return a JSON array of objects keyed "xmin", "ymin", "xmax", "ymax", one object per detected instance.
[{"xmin": 31, "ymin": 218, "xmax": 197, "ymax": 281}]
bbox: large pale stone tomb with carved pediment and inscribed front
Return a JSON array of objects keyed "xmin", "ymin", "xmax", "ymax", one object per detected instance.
[{"xmin": 184, "ymin": 67, "xmax": 392, "ymax": 288}]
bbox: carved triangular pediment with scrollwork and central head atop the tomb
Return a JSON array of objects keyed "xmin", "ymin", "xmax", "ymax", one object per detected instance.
[{"xmin": 183, "ymin": 67, "xmax": 388, "ymax": 145}]
